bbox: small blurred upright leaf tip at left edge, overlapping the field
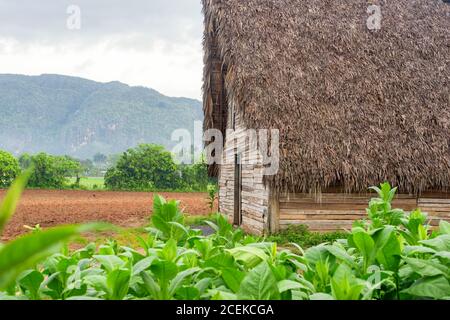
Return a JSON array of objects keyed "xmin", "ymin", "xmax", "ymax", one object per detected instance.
[{"xmin": 0, "ymin": 169, "xmax": 32, "ymax": 235}]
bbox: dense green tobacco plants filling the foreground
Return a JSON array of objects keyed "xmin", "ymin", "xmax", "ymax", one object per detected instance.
[{"xmin": 0, "ymin": 184, "xmax": 450, "ymax": 300}]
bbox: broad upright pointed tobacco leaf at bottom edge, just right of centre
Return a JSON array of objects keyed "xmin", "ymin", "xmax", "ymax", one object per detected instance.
[{"xmin": 238, "ymin": 262, "xmax": 280, "ymax": 300}]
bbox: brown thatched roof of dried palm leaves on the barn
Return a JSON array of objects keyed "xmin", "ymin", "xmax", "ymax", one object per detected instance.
[{"xmin": 203, "ymin": 0, "xmax": 450, "ymax": 192}]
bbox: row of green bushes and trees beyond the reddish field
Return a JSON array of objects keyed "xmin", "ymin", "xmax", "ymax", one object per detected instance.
[{"xmin": 0, "ymin": 144, "xmax": 215, "ymax": 191}]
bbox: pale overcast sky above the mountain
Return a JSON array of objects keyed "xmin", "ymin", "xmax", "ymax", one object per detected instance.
[{"xmin": 0, "ymin": 0, "xmax": 203, "ymax": 99}]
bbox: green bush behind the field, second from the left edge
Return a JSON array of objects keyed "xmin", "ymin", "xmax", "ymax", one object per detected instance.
[{"xmin": 28, "ymin": 153, "xmax": 81, "ymax": 189}]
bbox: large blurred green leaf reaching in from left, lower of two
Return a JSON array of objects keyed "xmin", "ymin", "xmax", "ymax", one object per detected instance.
[{"xmin": 0, "ymin": 224, "xmax": 104, "ymax": 289}]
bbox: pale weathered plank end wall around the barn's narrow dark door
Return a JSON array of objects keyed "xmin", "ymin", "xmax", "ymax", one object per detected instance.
[{"xmin": 219, "ymin": 106, "xmax": 269, "ymax": 234}]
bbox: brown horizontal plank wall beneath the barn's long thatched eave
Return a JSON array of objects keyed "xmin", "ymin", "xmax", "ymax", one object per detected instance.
[{"xmin": 279, "ymin": 193, "xmax": 450, "ymax": 231}]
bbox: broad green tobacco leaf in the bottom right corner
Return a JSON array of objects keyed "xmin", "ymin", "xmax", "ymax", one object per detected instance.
[{"xmin": 402, "ymin": 276, "xmax": 450, "ymax": 299}]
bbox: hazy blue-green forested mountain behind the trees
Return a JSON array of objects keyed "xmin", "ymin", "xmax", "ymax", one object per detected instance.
[{"xmin": 0, "ymin": 74, "xmax": 203, "ymax": 158}]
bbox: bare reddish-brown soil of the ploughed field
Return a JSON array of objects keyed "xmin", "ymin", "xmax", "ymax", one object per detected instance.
[{"xmin": 0, "ymin": 190, "xmax": 214, "ymax": 240}]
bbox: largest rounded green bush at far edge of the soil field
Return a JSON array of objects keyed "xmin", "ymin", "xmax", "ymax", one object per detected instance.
[{"xmin": 105, "ymin": 144, "xmax": 181, "ymax": 190}]
